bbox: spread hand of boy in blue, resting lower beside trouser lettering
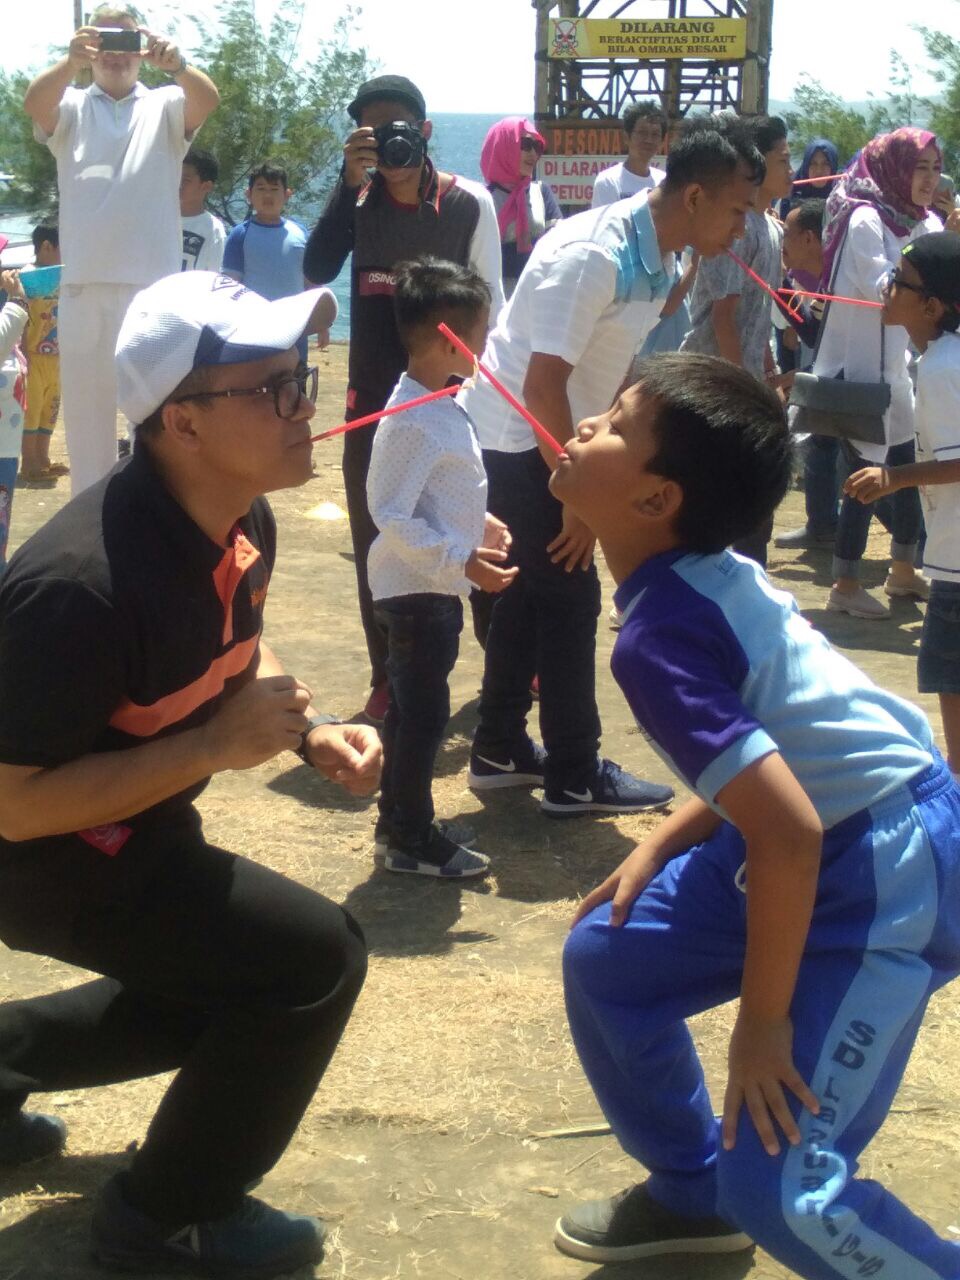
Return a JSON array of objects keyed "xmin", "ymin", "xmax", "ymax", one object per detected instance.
[{"xmin": 723, "ymin": 1007, "xmax": 820, "ymax": 1156}]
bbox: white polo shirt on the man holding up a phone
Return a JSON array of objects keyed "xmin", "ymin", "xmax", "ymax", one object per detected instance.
[{"xmin": 33, "ymin": 82, "xmax": 189, "ymax": 285}]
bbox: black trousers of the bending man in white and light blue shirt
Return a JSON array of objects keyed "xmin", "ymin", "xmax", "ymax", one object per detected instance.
[{"xmin": 474, "ymin": 449, "xmax": 600, "ymax": 785}]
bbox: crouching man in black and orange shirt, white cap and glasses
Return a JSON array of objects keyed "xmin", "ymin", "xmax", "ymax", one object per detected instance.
[{"xmin": 0, "ymin": 271, "xmax": 380, "ymax": 1276}]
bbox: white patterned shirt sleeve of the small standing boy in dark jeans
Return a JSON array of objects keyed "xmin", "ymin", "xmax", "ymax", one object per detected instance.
[{"xmin": 366, "ymin": 413, "xmax": 474, "ymax": 595}]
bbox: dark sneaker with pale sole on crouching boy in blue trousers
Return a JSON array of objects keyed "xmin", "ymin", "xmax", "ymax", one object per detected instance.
[{"xmin": 553, "ymin": 1183, "xmax": 754, "ymax": 1262}]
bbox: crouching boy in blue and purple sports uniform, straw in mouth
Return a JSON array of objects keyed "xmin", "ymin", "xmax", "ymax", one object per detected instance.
[{"xmin": 552, "ymin": 355, "xmax": 960, "ymax": 1280}]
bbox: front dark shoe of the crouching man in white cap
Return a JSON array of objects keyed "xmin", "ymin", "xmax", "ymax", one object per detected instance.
[{"xmin": 92, "ymin": 1175, "xmax": 325, "ymax": 1280}]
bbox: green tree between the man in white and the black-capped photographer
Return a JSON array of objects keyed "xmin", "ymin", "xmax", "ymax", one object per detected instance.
[{"xmin": 189, "ymin": 0, "xmax": 371, "ymax": 223}]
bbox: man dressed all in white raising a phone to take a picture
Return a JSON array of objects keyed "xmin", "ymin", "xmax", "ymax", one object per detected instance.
[{"xmin": 23, "ymin": 4, "xmax": 220, "ymax": 497}]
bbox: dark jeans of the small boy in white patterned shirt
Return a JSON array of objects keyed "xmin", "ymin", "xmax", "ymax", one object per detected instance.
[{"xmin": 376, "ymin": 593, "xmax": 463, "ymax": 847}]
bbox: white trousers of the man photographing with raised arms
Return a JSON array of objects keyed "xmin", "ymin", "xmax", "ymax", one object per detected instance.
[{"xmin": 58, "ymin": 284, "xmax": 142, "ymax": 498}]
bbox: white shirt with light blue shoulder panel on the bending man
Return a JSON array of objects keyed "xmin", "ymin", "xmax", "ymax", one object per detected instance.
[{"xmin": 458, "ymin": 191, "xmax": 677, "ymax": 453}]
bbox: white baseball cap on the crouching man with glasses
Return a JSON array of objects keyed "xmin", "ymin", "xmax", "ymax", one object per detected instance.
[{"xmin": 116, "ymin": 271, "xmax": 333, "ymax": 424}]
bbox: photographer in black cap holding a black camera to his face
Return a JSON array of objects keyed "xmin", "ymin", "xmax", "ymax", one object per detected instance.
[{"xmin": 303, "ymin": 76, "xmax": 503, "ymax": 721}]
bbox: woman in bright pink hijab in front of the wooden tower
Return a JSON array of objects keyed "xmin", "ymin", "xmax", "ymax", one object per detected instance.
[{"xmin": 480, "ymin": 115, "xmax": 563, "ymax": 297}]
